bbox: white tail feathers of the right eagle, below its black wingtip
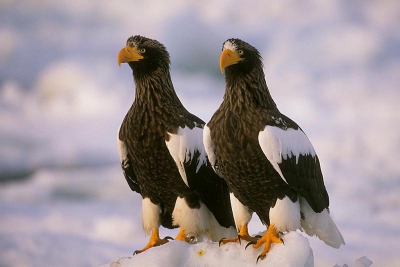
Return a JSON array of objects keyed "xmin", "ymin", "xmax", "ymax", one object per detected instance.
[{"xmin": 300, "ymin": 197, "xmax": 345, "ymax": 248}]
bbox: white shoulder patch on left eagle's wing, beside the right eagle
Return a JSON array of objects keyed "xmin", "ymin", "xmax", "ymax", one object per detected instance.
[{"xmin": 166, "ymin": 127, "xmax": 206, "ymax": 186}]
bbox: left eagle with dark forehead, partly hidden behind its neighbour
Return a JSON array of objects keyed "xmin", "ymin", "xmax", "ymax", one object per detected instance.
[{"xmin": 117, "ymin": 35, "xmax": 236, "ymax": 254}]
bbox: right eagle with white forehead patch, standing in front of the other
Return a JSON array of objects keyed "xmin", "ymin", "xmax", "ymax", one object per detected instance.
[{"xmin": 203, "ymin": 38, "xmax": 345, "ymax": 261}]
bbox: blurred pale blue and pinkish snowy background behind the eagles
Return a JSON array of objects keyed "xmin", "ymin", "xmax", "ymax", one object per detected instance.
[{"xmin": 0, "ymin": 0, "xmax": 400, "ymax": 266}]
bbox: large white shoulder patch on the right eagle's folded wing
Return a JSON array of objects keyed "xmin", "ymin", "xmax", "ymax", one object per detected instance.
[{"xmin": 258, "ymin": 125, "xmax": 316, "ymax": 182}]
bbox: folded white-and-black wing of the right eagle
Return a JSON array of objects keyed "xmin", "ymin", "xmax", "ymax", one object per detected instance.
[{"xmin": 258, "ymin": 125, "xmax": 329, "ymax": 212}]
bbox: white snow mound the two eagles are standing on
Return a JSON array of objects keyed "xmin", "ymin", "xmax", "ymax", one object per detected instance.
[{"xmin": 102, "ymin": 232, "xmax": 314, "ymax": 267}]
